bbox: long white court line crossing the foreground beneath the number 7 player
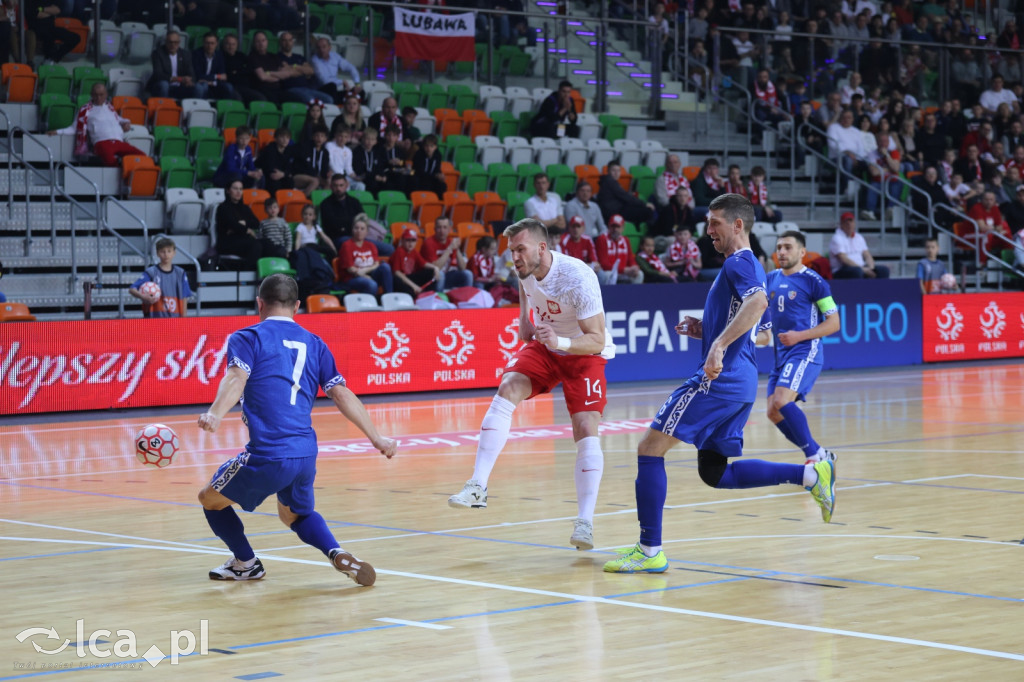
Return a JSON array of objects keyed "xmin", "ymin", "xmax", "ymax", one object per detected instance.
[{"xmin": 0, "ymin": 536, "xmax": 1024, "ymax": 662}]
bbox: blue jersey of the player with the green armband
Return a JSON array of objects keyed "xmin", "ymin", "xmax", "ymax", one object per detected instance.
[{"xmin": 768, "ymin": 267, "xmax": 838, "ymax": 367}]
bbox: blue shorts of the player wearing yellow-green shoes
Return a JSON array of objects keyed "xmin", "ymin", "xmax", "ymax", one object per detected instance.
[{"xmin": 650, "ymin": 381, "xmax": 754, "ymax": 457}]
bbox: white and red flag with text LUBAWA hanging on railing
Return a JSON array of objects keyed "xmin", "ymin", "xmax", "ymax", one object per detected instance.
[{"xmin": 394, "ymin": 7, "xmax": 476, "ymax": 61}]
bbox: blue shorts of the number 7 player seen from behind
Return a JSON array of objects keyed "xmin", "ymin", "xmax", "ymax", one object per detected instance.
[{"xmin": 210, "ymin": 453, "xmax": 316, "ymax": 516}]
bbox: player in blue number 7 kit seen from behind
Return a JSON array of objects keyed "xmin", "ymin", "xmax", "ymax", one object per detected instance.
[{"xmin": 199, "ymin": 274, "xmax": 395, "ymax": 585}]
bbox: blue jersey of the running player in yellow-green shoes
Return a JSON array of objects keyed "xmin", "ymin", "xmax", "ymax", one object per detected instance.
[{"xmin": 691, "ymin": 249, "xmax": 766, "ymax": 402}]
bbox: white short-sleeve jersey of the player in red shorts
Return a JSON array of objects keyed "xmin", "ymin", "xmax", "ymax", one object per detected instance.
[{"xmin": 521, "ymin": 251, "xmax": 615, "ymax": 359}]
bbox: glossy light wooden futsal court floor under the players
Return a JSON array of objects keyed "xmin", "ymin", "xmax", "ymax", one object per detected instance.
[{"xmin": 0, "ymin": 364, "xmax": 1024, "ymax": 681}]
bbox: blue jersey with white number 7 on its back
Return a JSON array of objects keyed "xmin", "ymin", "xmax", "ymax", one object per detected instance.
[{"xmin": 227, "ymin": 317, "xmax": 345, "ymax": 459}]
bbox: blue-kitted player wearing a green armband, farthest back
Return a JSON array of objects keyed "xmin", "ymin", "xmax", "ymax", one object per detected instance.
[{"xmin": 758, "ymin": 230, "xmax": 840, "ymax": 464}]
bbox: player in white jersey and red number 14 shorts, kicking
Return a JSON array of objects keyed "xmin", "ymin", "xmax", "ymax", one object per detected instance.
[{"xmin": 449, "ymin": 218, "xmax": 615, "ymax": 550}]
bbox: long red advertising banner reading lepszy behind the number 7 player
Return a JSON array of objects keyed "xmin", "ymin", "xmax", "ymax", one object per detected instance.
[{"xmin": 0, "ymin": 308, "xmax": 521, "ymax": 415}]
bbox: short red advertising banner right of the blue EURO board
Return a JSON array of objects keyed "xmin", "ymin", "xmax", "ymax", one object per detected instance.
[{"xmin": 922, "ymin": 292, "xmax": 1024, "ymax": 363}]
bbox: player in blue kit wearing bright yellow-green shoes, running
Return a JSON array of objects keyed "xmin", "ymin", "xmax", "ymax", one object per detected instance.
[{"xmin": 604, "ymin": 194, "xmax": 836, "ymax": 573}]
